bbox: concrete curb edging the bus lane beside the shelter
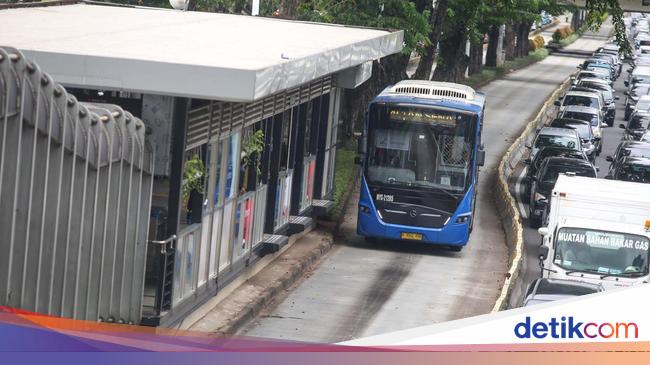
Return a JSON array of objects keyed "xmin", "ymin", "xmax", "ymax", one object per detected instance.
[{"xmin": 213, "ymin": 234, "xmax": 334, "ymax": 336}]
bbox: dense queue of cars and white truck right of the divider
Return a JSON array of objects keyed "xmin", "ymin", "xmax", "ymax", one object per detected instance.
[{"xmin": 522, "ymin": 14, "xmax": 650, "ymax": 306}]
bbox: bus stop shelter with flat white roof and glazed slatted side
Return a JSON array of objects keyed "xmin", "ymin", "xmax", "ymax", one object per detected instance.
[{"xmin": 0, "ymin": 2, "xmax": 403, "ymax": 325}]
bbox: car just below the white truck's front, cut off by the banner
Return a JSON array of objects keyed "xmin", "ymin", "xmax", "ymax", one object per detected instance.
[{"xmin": 522, "ymin": 278, "xmax": 605, "ymax": 307}]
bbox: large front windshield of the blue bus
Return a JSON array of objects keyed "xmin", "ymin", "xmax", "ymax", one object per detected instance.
[{"xmin": 366, "ymin": 104, "xmax": 477, "ymax": 193}]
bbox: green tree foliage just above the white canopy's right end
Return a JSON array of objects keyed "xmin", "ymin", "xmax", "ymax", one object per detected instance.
[{"xmin": 298, "ymin": 0, "xmax": 431, "ymax": 54}]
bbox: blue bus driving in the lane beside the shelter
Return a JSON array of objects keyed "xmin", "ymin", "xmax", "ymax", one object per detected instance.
[{"xmin": 357, "ymin": 80, "xmax": 485, "ymax": 251}]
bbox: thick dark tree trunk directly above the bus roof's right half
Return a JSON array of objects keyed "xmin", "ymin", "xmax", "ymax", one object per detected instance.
[{"xmin": 433, "ymin": 24, "xmax": 469, "ymax": 82}]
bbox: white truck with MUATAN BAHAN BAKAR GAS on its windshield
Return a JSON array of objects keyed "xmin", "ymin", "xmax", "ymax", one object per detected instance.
[{"xmin": 538, "ymin": 175, "xmax": 650, "ymax": 289}]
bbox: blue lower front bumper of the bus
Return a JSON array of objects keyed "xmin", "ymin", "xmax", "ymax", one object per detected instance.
[{"xmin": 357, "ymin": 209, "xmax": 472, "ymax": 246}]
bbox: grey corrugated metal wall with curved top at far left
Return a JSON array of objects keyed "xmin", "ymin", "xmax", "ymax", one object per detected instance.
[{"xmin": 0, "ymin": 47, "xmax": 153, "ymax": 323}]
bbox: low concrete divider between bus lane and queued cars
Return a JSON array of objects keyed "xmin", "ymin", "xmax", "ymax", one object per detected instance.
[{"xmin": 492, "ymin": 78, "xmax": 571, "ymax": 312}]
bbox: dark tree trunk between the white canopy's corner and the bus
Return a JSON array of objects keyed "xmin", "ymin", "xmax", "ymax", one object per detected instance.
[{"xmin": 341, "ymin": 53, "xmax": 410, "ymax": 139}]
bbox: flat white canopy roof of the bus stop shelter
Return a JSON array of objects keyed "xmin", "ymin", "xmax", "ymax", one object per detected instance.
[{"xmin": 0, "ymin": 4, "xmax": 403, "ymax": 101}]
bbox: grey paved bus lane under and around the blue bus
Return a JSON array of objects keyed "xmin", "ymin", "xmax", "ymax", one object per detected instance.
[{"xmin": 240, "ymin": 25, "xmax": 611, "ymax": 342}]
